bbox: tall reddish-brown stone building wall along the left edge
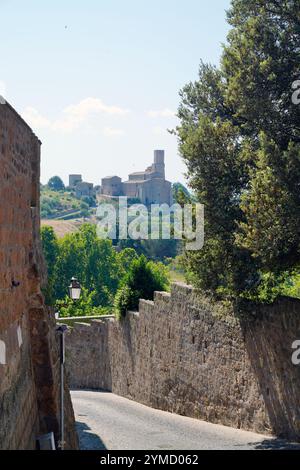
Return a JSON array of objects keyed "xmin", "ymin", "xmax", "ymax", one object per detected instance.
[{"xmin": 0, "ymin": 104, "xmax": 77, "ymax": 449}]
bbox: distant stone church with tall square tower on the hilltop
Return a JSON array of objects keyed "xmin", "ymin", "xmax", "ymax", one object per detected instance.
[{"xmin": 101, "ymin": 150, "xmax": 172, "ymax": 205}]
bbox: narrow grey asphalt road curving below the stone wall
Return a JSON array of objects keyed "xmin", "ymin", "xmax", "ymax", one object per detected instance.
[{"xmin": 72, "ymin": 390, "xmax": 300, "ymax": 450}]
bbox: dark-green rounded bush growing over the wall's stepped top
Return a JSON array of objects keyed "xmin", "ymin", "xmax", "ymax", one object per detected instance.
[{"xmin": 114, "ymin": 255, "xmax": 169, "ymax": 319}]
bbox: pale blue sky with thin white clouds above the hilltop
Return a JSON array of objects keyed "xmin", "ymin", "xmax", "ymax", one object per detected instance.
[{"xmin": 0, "ymin": 0, "xmax": 230, "ymax": 184}]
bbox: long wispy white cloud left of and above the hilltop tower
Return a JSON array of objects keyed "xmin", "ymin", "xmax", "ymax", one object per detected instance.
[{"xmin": 22, "ymin": 98, "xmax": 130, "ymax": 132}]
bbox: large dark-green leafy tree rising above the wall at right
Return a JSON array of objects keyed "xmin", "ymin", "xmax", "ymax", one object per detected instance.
[{"xmin": 176, "ymin": 0, "xmax": 300, "ymax": 301}]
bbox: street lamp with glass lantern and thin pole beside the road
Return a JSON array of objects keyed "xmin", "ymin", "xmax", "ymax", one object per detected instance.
[{"xmin": 57, "ymin": 277, "xmax": 81, "ymax": 450}]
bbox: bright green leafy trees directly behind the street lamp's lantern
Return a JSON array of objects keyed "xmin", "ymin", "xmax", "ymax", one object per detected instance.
[{"xmin": 42, "ymin": 224, "xmax": 120, "ymax": 310}]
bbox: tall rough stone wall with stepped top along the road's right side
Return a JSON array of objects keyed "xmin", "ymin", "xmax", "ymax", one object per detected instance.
[{"xmin": 67, "ymin": 284, "xmax": 300, "ymax": 439}]
